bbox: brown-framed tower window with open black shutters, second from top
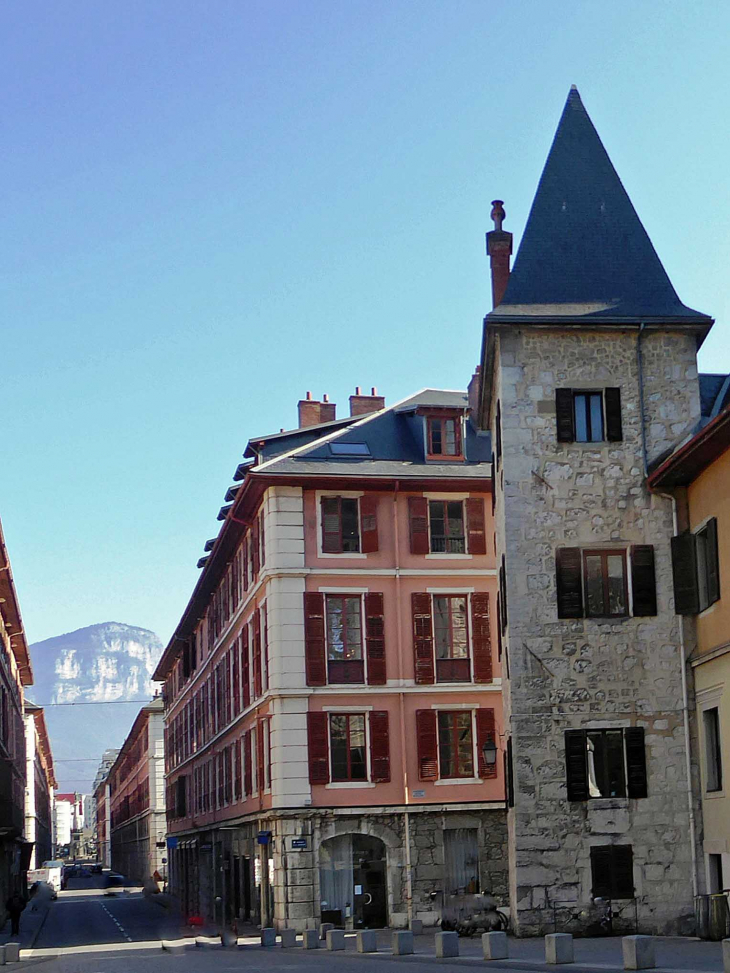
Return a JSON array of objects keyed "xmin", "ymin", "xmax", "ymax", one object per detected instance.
[{"xmin": 555, "ymin": 544, "xmax": 657, "ymax": 618}]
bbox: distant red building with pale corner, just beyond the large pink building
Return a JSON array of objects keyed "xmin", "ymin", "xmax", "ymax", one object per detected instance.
[{"xmin": 105, "ymin": 698, "xmax": 166, "ymax": 884}]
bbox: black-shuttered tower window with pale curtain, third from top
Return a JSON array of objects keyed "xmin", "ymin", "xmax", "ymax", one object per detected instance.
[{"xmin": 565, "ymin": 726, "xmax": 647, "ymax": 801}]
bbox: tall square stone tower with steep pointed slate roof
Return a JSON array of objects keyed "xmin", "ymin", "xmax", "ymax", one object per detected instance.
[{"xmin": 480, "ymin": 88, "xmax": 712, "ymax": 935}]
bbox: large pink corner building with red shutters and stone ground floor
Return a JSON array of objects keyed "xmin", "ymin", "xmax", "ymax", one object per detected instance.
[{"xmin": 156, "ymin": 390, "xmax": 507, "ymax": 929}]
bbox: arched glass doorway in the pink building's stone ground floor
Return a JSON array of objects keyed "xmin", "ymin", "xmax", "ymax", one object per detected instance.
[{"xmin": 319, "ymin": 834, "xmax": 388, "ymax": 929}]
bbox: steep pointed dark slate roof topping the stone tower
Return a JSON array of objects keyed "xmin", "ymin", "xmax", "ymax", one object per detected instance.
[{"xmin": 487, "ymin": 87, "xmax": 711, "ymax": 324}]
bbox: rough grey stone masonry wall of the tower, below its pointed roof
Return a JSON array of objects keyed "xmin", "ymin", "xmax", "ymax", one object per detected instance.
[{"xmin": 494, "ymin": 326, "xmax": 699, "ymax": 935}]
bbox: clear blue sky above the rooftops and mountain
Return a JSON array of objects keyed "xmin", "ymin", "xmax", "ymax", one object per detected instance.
[{"xmin": 0, "ymin": 0, "xmax": 730, "ymax": 652}]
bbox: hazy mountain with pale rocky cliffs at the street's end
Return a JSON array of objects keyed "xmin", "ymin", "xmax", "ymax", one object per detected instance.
[{"xmin": 28, "ymin": 622, "xmax": 163, "ymax": 793}]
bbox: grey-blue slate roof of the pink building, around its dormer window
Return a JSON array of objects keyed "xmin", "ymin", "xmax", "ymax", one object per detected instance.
[{"xmin": 252, "ymin": 389, "xmax": 492, "ymax": 478}]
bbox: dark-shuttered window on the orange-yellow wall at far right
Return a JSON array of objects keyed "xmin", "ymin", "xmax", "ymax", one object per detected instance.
[{"xmin": 672, "ymin": 517, "xmax": 720, "ymax": 615}]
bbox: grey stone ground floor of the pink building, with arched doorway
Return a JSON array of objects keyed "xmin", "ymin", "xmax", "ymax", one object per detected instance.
[{"xmin": 169, "ymin": 805, "xmax": 508, "ymax": 932}]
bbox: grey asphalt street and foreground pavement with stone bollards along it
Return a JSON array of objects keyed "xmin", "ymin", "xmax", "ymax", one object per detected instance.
[{"xmin": 9, "ymin": 877, "xmax": 722, "ymax": 973}]
